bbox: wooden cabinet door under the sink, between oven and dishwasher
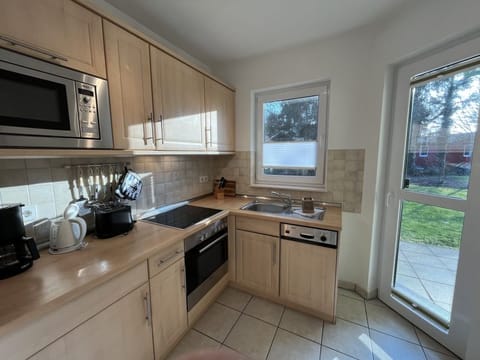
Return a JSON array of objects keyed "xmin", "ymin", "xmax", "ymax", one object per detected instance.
[{"xmin": 235, "ymin": 230, "xmax": 280, "ymax": 296}]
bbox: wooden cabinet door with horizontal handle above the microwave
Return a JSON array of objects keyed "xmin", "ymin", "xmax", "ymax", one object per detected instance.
[{"xmin": 0, "ymin": 0, "xmax": 106, "ymax": 78}]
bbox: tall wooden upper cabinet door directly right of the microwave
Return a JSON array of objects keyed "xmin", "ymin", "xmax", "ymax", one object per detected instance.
[{"xmin": 103, "ymin": 20, "xmax": 155, "ymax": 150}]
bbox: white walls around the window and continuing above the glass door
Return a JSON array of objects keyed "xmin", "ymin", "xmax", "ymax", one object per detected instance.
[{"xmin": 216, "ymin": 0, "xmax": 480, "ymax": 300}]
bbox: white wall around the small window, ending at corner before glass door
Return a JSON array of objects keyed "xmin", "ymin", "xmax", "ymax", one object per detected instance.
[{"xmin": 216, "ymin": 27, "xmax": 377, "ymax": 289}]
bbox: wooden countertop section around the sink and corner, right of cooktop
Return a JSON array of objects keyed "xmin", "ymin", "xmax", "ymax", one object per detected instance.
[{"xmin": 190, "ymin": 196, "xmax": 342, "ymax": 231}]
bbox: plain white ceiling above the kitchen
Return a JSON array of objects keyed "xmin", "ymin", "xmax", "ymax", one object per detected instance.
[{"xmin": 106, "ymin": 0, "xmax": 408, "ymax": 63}]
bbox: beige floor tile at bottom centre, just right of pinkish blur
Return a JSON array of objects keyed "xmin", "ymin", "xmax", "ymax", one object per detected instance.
[{"xmin": 225, "ymin": 314, "xmax": 276, "ymax": 360}]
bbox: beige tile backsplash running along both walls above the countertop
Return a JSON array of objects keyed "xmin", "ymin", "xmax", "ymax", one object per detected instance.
[{"xmin": 0, "ymin": 150, "xmax": 365, "ymax": 222}]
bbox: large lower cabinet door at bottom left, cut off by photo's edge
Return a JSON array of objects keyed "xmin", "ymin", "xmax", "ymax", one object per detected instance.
[{"xmin": 30, "ymin": 283, "xmax": 154, "ymax": 360}]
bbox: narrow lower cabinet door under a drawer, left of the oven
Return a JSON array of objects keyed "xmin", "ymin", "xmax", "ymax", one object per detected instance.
[{"xmin": 150, "ymin": 258, "xmax": 187, "ymax": 359}]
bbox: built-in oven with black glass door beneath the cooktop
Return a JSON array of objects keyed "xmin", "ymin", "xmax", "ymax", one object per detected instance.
[{"xmin": 185, "ymin": 218, "xmax": 228, "ymax": 310}]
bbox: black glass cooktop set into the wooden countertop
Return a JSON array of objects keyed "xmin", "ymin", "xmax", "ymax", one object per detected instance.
[{"xmin": 142, "ymin": 205, "xmax": 222, "ymax": 229}]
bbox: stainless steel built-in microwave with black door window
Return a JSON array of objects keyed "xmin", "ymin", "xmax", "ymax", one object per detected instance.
[{"xmin": 0, "ymin": 49, "xmax": 113, "ymax": 149}]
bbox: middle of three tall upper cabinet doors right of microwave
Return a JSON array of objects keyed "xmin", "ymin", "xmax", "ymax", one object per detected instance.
[{"xmin": 150, "ymin": 46, "xmax": 206, "ymax": 151}]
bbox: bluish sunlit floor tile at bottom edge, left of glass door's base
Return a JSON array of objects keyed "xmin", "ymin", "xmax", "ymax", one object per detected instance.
[{"xmin": 370, "ymin": 330, "xmax": 425, "ymax": 360}]
